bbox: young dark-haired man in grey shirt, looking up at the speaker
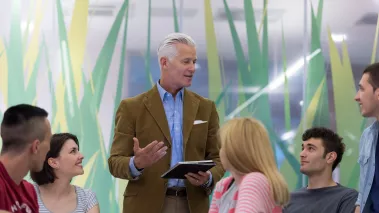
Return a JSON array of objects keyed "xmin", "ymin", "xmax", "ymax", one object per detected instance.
[{"xmin": 283, "ymin": 127, "xmax": 358, "ymax": 213}]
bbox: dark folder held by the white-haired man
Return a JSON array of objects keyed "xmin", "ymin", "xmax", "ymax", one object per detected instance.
[{"xmin": 161, "ymin": 160, "xmax": 216, "ymax": 179}]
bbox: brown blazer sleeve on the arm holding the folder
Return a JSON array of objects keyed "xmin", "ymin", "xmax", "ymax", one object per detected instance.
[{"xmin": 205, "ymin": 101, "xmax": 225, "ymax": 195}]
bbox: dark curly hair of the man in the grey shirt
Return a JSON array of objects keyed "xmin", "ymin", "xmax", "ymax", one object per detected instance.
[{"xmin": 302, "ymin": 127, "xmax": 345, "ymax": 171}]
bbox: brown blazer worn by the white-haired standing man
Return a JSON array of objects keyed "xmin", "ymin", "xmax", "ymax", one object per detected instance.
[{"xmin": 108, "ymin": 85, "xmax": 225, "ymax": 213}]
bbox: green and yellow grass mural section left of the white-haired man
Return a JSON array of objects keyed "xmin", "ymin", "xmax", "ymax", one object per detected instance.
[{"xmin": 0, "ymin": 0, "xmax": 128, "ymax": 212}]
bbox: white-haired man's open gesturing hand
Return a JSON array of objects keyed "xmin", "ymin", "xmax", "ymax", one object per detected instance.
[{"xmin": 133, "ymin": 137, "xmax": 167, "ymax": 169}]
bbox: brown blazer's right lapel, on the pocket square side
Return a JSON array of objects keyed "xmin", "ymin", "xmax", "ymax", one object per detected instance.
[{"xmin": 183, "ymin": 89, "xmax": 199, "ymax": 147}]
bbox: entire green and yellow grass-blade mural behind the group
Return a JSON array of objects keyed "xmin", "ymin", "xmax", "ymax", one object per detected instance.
[{"xmin": 0, "ymin": 0, "xmax": 379, "ymax": 212}]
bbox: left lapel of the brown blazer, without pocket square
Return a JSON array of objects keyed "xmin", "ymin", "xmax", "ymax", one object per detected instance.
[{"xmin": 143, "ymin": 85, "xmax": 171, "ymax": 144}]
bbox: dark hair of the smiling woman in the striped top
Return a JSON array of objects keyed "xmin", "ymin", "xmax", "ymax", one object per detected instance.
[{"xmin": 30, "ymin": 133, "xmax": 79, "ymax": 185}]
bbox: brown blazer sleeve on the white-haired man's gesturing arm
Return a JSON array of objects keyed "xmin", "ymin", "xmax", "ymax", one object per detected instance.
[{"xmin": 108, "ymin": 99, "xmax": 135, "ymax": 180}]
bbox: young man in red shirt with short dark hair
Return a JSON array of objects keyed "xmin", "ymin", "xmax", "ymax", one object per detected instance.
[{"xmin": 0, "ymin": 104, "xmax": 51, "ymax": 213}]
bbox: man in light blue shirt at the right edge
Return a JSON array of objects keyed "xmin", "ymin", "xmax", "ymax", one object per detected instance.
[{"xmin": 354, "ymin": 63, "xmax": 379, "ymax": 213}]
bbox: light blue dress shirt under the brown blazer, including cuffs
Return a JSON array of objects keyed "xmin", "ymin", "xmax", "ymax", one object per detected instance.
[{"xmin": 129, "ymin": 82, "xmax": 212, "ymax": 187}]
